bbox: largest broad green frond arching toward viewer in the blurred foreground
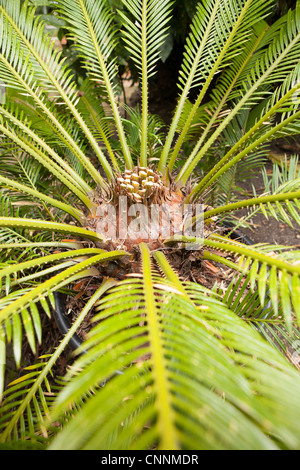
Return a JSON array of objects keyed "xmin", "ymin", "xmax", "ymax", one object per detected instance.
[{"xmin": 45, "ymin": 254, "xmax": 299, "ymax": 450}]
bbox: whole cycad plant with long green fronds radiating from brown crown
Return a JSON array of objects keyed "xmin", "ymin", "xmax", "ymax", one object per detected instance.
[{"xmin": 0, "ymin": 0, "xmax": 300, "ymax": 450}]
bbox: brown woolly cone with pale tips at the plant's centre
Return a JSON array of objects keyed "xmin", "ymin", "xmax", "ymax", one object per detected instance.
[{"xmin": 87, "ymin": 166, "xmax": 184, "ymax": 251}]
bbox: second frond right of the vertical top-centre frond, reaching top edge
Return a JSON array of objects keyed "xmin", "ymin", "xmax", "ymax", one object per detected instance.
[{"xmin": 159, "ymin": 0, "xmax": 271, "ymax": 171}]
